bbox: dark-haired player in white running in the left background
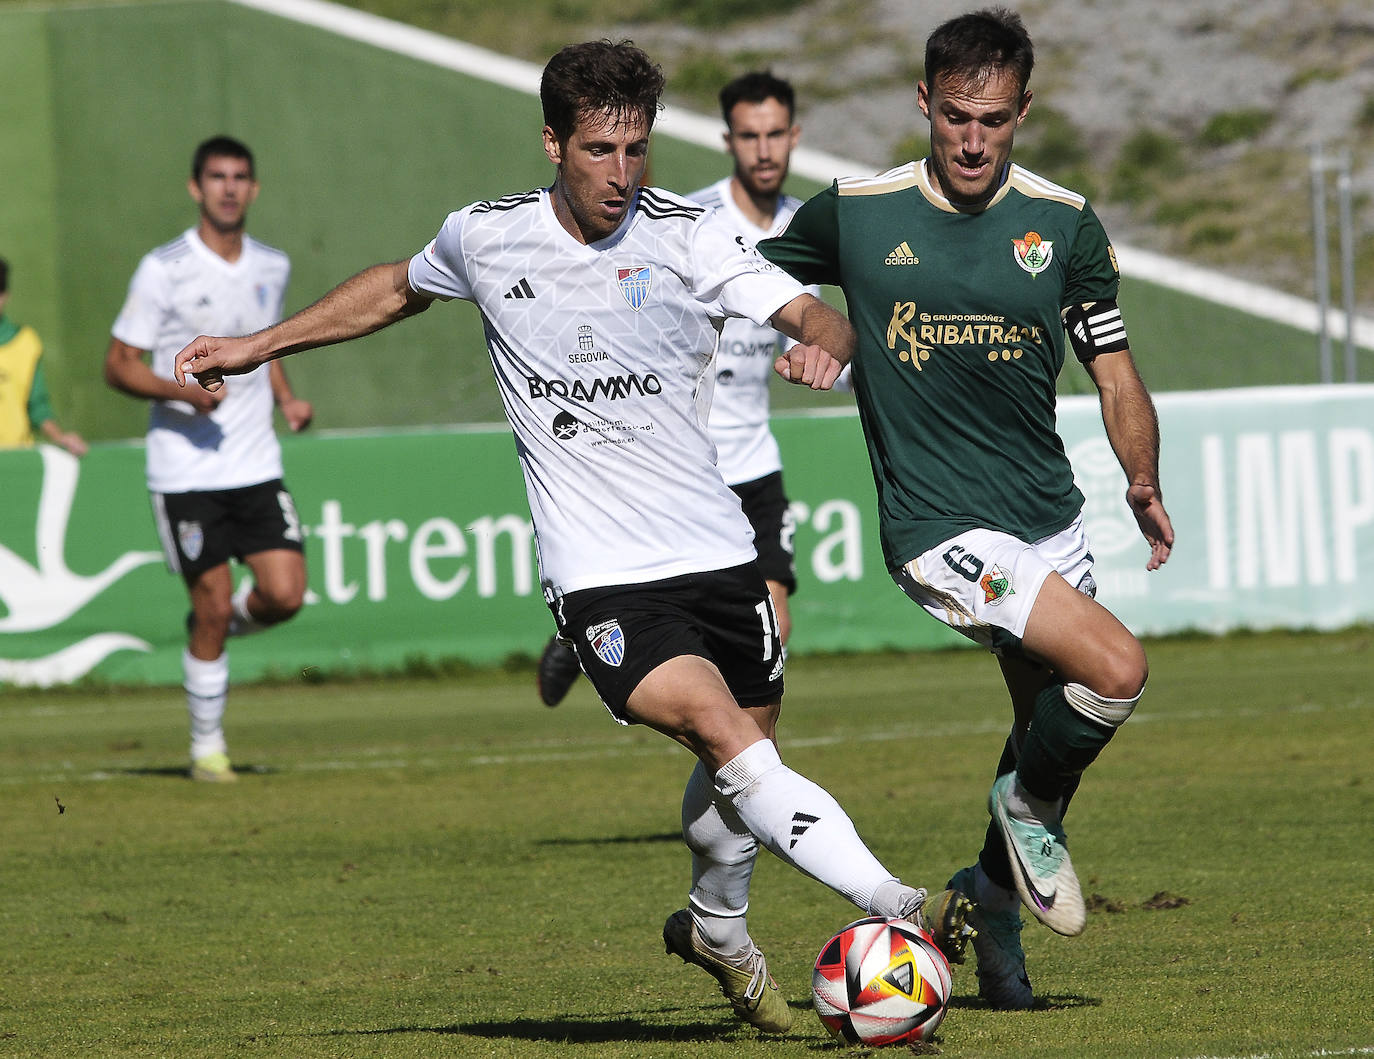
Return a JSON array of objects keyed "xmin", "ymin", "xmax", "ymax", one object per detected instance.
[{"xmin": 104, "ymin": 136, "xmax": 313, "ymax": 783}]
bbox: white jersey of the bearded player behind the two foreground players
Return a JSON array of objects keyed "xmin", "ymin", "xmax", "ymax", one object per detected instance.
[{"xmin": 688, "ymin": 177, "xmax": 802, "ymax": 485}]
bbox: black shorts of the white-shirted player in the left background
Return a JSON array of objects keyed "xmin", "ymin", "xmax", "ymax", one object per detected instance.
[{"xmin": 151, "ymin": 479, "xmax": 304, "ymax": 577}]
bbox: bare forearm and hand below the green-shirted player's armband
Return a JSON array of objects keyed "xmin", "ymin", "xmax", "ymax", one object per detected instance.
[{"xmin": 1087, "ymin": 350, "xmax": 1173, "ymax": 570}]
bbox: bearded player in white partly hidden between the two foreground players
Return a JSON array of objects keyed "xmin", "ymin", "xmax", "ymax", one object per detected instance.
[{"xmin": 539, "ymin": 71, "xmax": 819, "ymax": 706}]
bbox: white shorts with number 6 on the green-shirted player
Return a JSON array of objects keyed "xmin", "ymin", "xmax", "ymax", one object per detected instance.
[{"xmin": 892, "ymin": 512, "xmax": 1098, "ymax": 654}]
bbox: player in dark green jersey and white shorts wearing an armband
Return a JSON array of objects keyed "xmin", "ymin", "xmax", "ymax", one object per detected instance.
[{"xmin": 760, "ymin": 8, "xmax": 1173, "ymax": 1008}]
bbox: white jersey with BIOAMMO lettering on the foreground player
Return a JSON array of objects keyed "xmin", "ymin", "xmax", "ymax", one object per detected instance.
[{"xmin": 409, "ymin": 188, "xmax": 802, "ymax": 596}]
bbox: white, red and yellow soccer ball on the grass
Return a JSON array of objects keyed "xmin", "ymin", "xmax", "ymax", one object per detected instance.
[{"xmin": 811, "ymin": 918, "xmax": 951, "ymax": 1045}]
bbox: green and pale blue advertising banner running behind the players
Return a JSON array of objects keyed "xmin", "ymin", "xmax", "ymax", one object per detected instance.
[{"xmin": 0, "ymin": 386, "xmax": 1374, "ymax": 685}]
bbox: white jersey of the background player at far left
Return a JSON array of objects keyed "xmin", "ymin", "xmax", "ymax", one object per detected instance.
[{"xmin": 110, "ymin": 228, "xmax": 291, "ymax": 493}]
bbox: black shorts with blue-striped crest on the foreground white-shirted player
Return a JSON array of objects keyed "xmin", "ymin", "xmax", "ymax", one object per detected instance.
[{"xmin": 550, "ymin": 563, "xmax": 783, "ymax": 724}]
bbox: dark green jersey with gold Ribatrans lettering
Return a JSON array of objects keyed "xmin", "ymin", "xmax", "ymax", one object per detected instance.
[{"xmin": 758, "ymin": 161, "xmax": 1120, "ymax": 569}]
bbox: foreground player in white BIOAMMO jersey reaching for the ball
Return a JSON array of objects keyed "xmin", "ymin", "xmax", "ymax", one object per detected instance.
[{"xmin": 166, "ymin": 41, "xmax": 967, "ymax": 1032}]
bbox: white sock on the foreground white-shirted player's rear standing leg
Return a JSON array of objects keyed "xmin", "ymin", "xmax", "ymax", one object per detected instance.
[{"xmin": 683, "ymin": 761, "xmax": 758, "ymax": 955}]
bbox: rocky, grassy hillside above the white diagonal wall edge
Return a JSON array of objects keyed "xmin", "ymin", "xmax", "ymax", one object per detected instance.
[{"xmin": 343, "ymin": 0, "xmax": 1374, "ymax": 312}]
